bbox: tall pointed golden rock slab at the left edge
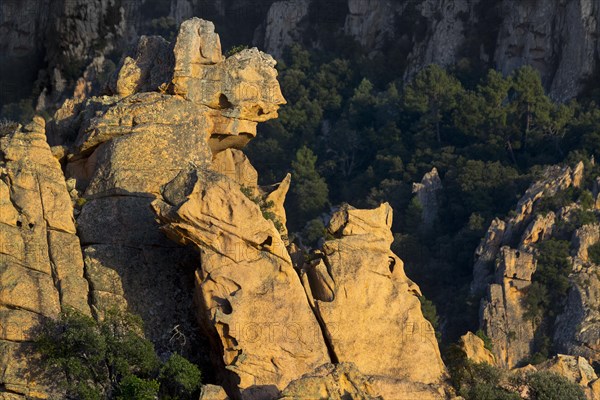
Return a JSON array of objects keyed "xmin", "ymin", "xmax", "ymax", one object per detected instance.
[{"xmin": 0, "ymin": 117, "xmax": 90, "ymax": 399}]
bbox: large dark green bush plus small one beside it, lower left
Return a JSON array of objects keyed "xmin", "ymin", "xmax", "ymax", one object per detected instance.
[{"xmin": 35, "ymin": 309, "xmax": 200, "ymax": 400}]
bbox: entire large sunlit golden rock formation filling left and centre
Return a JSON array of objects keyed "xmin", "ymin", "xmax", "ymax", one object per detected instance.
[{"xmin": 0, "ymin": 18, "xmax": 454, "ymax": 400}]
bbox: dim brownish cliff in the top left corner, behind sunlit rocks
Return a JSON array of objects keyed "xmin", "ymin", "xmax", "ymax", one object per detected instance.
[{"xmin": 0, "ymin": 0, "xmax": 141, "ymax": 106}]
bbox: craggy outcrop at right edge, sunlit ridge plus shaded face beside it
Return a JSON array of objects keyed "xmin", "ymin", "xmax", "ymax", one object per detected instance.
[{"xmin": 471, "ymin": 163, "xmax": 600, "ymax": 368}]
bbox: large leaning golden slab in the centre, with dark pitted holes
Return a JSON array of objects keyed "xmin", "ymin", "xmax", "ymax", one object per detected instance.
[{"xmin": 154, "ymin": 171, "xmax": 329, "ymax": 398}]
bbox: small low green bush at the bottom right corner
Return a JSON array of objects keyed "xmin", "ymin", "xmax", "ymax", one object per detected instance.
[{"xmin": 527, "ymin": 372, "xmax": 586, "ymax": 400}]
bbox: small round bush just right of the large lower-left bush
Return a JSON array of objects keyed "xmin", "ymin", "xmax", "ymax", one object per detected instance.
[{"xmin": 159, "ymin": 354, "xmax": 201, "ymax": 400}]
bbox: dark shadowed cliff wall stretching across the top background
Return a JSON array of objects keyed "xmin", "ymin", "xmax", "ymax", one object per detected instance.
[{"xmin": 5, "ymin": 0, "xmax": 600, "ymax": 116}]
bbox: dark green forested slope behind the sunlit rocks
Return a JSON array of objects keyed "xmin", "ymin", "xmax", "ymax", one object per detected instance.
[{"xmin": 247, "ymin": 41, "xmax": 600, "ymax": 346}]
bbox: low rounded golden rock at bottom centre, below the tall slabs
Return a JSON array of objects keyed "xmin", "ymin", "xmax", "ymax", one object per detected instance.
[{"xmin": 280, "ymin": 362, "xmax": 381, "ymax": 400}]
